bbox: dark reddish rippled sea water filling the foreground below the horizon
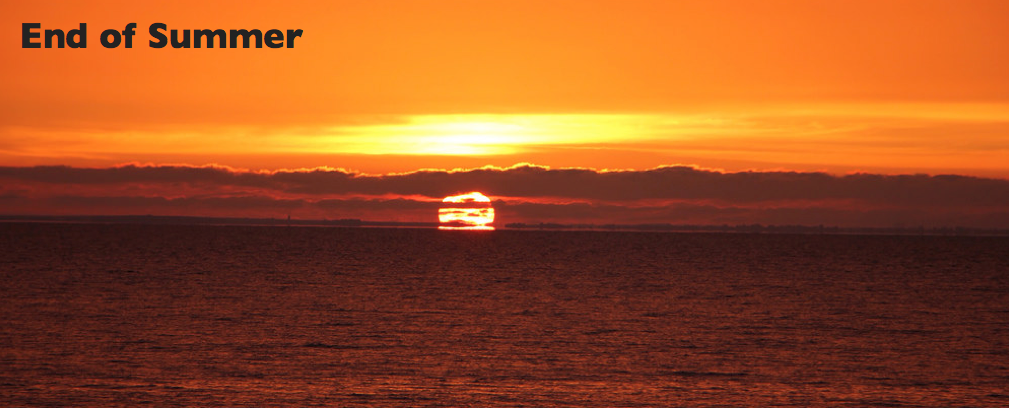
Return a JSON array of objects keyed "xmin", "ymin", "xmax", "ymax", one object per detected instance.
[{"xmin": 0, "ymin": 224, "xmax": 1009, "ymax": 407}]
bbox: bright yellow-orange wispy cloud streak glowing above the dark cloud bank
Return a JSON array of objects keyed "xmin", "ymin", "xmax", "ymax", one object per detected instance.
[{"xmin": 0, "ymin": 102, "xmax": 1009, "ymax": 175}]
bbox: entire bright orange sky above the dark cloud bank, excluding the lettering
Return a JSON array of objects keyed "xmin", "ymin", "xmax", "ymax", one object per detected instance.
[{"xmin": 0, "ymin": 0, "xmax": 1009, "ymax": 178}]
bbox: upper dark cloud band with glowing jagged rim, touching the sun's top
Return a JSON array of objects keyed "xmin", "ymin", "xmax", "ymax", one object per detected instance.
[{"xmin": 0, "ymin": 166, "xmax": 1009, "ymax": 206}]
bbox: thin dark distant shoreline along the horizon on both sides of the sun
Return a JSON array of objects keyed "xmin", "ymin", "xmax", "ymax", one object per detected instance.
[{"xmin": 0, "ymin": 215, "xmax": 1009, "ymax": 236}]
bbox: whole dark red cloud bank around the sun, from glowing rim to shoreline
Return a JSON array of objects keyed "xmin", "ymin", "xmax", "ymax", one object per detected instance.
[{"xmin": 0, "ymin": 165, "xmax": 1009, "ymax": 227}]
